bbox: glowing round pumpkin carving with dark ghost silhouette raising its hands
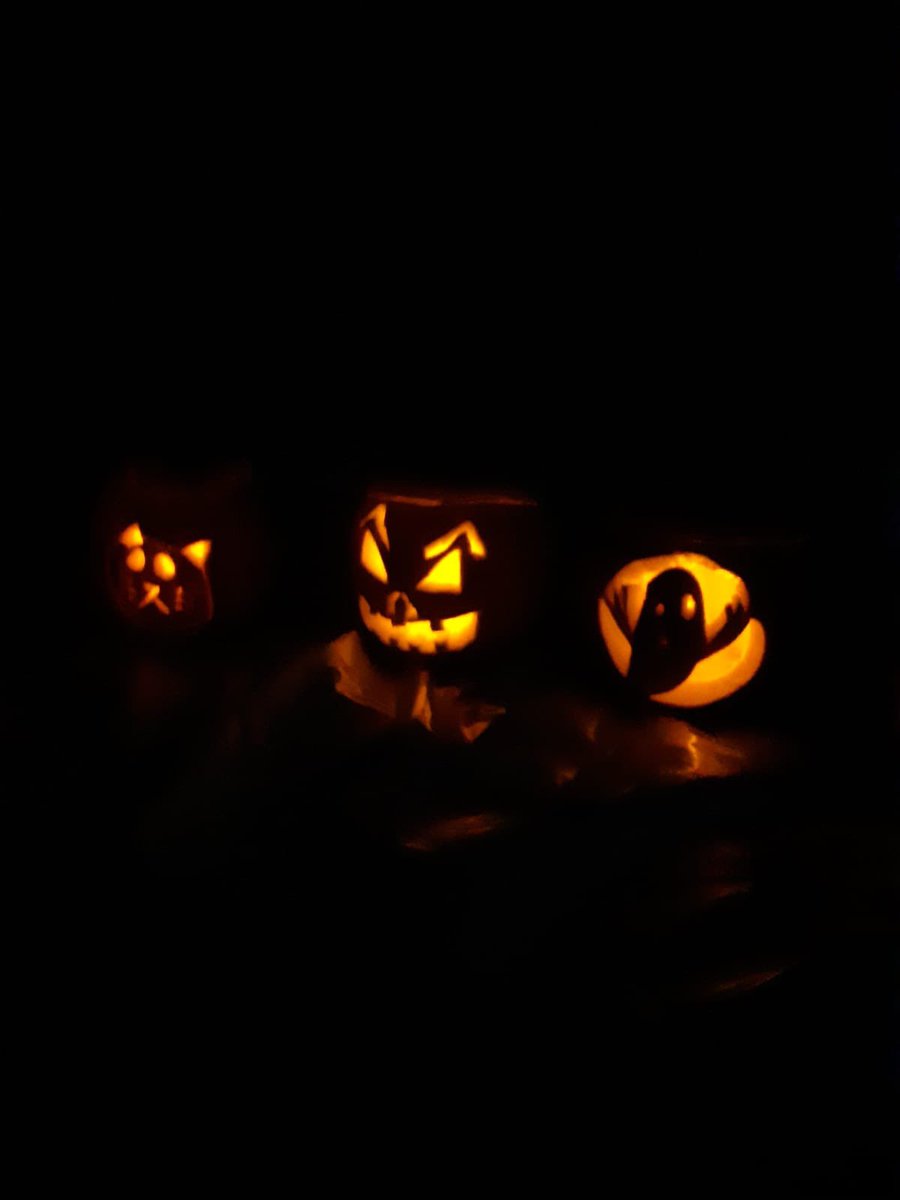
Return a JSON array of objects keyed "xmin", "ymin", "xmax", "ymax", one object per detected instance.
[{"xmin": 598, "ymin": 553, "xmax": 766, "ymax": 708}]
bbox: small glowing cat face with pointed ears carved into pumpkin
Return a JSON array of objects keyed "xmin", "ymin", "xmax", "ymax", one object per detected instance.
[{"xmin": 110, "ymin": 523, "xmax": 212, "ymax": 630}]
